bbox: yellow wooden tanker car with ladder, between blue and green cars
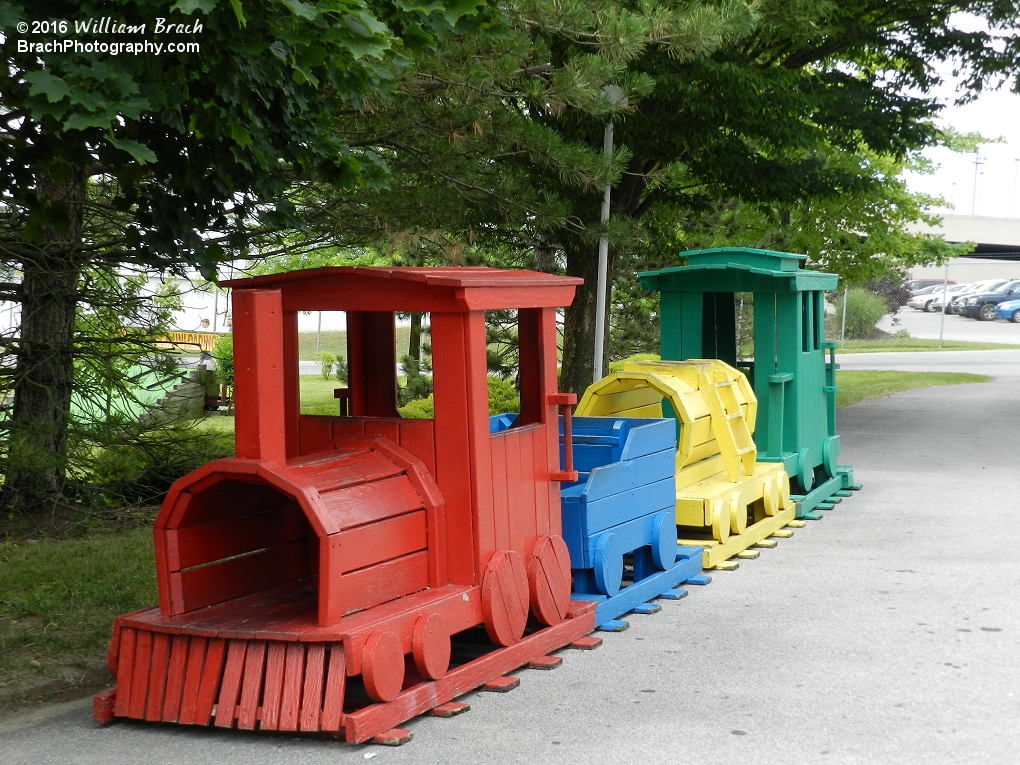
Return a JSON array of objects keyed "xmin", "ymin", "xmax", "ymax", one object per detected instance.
[{"xmin": 576, "ymin": 359, "xmax": 796, "ymax": 568}]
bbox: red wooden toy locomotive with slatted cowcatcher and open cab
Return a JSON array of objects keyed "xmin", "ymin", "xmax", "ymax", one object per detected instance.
[{"xmin": 96, "ymin": 268, "xmax": 595, "ymax": 743}]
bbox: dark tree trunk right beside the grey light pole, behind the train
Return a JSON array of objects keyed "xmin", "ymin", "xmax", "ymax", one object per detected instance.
[{"xmin": 560, "ymin": 242, "xmax": 613, "ymax": 399}]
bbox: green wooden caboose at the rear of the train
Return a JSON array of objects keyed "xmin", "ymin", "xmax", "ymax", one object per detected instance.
[{"xmin": 639, "ymin": 247, "xmax": 859, "ymax": 518}]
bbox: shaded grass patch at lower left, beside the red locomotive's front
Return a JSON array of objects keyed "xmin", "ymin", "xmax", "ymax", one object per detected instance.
[{"xmin": 0, "ymin": 526, "xmax": 157, "ymax": 712}]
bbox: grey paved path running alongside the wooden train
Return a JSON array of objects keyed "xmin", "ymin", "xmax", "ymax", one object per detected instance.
[{"xmin": 0, "ymin": 354, "xmax": 1020, "ymax": 765}]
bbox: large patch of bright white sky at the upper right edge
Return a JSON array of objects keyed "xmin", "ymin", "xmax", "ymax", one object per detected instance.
[{"xmin": 906, "ymin": 20, "xmax": 1020, "ymax": 217}]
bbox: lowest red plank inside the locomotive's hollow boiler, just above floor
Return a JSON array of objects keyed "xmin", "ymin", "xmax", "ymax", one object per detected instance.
[{"xmin": 170, "ymin": 541, "xmax": 310, "ymax": 611}]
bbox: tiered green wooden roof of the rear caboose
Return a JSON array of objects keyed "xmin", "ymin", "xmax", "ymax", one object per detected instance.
[{"xmin": 638, "ymin": 247, "xmax": 839, "ymax": 293}]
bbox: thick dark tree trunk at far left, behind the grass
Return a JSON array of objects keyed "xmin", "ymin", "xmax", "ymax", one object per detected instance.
[{"xmin": 2, "ymin": 171, "xmax": 85, "ymax": 514}]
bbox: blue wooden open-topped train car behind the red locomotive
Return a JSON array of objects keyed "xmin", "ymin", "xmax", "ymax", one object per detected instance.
[{"xmin": 490, "ymin": 414, "xmax": 711, "ymax": 629}]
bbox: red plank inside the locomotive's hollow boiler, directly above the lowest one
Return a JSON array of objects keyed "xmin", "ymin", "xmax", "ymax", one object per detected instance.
[{"xmin": 167, "ymin": 505, "xmax": 309, "ymax": 570}]
